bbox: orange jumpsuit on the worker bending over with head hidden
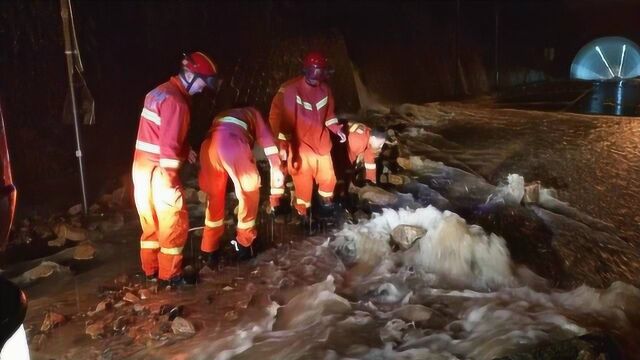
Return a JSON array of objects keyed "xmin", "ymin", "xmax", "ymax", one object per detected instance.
[{"xmin": 199, "ymin": 107, "xmax": 280, "ymax": 253}]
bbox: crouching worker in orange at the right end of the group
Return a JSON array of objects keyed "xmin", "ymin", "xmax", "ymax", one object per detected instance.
[{"xmin": 336, "ymin": 122, "xmax": 387, "ymax": 201}]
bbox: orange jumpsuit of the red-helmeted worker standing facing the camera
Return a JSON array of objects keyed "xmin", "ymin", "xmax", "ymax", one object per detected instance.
[{"xmin": 269, "ymin": 76, "xmax": 341, "ymax": 215}]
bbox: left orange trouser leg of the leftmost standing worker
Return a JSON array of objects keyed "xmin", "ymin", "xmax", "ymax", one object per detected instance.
[{"xmin": 132, "ymin": 152, "xmax": 160, "ymax": 275}]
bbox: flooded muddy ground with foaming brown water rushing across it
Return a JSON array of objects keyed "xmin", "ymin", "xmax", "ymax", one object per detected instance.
[{"xmin": 12, "ymin": 103, "xmax": 640, "ymax": 359}]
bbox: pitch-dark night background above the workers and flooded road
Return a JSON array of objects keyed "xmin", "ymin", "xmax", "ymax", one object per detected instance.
[{"xmin": 0, "ymin": 0, "xmax": 640, "ymax": 212}]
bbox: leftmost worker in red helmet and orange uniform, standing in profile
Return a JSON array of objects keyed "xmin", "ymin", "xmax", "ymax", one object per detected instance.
[{"xmin": 132, "ymin": 52, "xmax": 217, "ymax": 285}]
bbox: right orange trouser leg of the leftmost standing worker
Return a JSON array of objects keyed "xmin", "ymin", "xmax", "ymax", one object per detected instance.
[{"xmin": 151, "ymin": 168, "xmax": 189, "ymax": 280}]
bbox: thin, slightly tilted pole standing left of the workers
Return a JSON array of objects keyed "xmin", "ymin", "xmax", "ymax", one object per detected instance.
[{"xmin": 60, "ymin": 0, "xmax": 89, "ymax": 215}]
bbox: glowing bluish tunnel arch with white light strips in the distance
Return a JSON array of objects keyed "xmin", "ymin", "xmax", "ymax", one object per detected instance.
[{"xmin": 571, "ymin": 36, "xmax": 640, "ymax": 80}]
